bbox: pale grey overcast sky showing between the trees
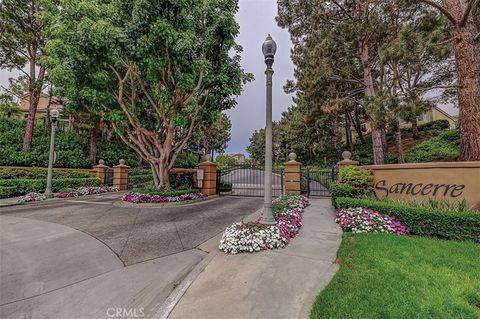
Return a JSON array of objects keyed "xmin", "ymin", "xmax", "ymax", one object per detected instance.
[{"xmin": 0, "ymin": 0, "xmax": 458, "ymax": 155}]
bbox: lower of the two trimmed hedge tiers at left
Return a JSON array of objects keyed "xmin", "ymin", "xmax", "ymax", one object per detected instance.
[{"xmin": 0, "ymin": 177, "xmax": 100, "ymax": 197}]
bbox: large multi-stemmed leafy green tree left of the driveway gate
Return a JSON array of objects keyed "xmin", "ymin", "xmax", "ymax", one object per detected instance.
[{"xmin": 45, "ymin": 0, "xmax": 250, "ymax": 188}]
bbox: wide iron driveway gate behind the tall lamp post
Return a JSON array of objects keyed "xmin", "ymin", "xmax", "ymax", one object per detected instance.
[{"xmin": 217, "ymin": 165, "xmax": 283, "ymax": 197}]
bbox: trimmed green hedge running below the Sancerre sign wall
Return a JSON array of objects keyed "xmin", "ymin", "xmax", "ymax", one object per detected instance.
[{"xmin": 335, "ymin": 197, "xmax": 480, "ymax": 243}]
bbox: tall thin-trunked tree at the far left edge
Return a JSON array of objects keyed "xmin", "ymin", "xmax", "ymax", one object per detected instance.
[{"xmin": 0, "ymin": 0, "xmax": 46, "ymax": 151}]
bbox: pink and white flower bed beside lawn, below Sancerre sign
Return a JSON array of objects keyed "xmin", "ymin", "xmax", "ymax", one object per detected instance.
[{"xmin": 335, "ymin": 207, "xmax": 408, "ymax": 235}]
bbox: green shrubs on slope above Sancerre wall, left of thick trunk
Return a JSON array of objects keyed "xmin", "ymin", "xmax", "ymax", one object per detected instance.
[{"xmin": 405, "ymin": 129, "xmax": 460, "ymax": 163}]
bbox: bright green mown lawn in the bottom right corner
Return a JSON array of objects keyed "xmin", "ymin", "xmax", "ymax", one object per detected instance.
[{"xmin": 311, "ymin": 233, "xmax": 480, "ymax": 319}]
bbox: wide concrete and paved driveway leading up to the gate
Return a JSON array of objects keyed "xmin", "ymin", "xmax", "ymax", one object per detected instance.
[{"xmin": 0, "ymin": 194, "xmax": 262, "ymax": 318}]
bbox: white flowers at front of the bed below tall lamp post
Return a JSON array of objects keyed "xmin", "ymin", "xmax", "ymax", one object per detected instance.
[{"xmin": 218, "ymin": 223, "xmax": 288, "ymax": 254}]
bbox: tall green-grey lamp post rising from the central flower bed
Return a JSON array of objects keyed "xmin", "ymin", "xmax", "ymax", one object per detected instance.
[{"xmin": 260, "ymin": 34, "xmax": 277, "ymax": 225}]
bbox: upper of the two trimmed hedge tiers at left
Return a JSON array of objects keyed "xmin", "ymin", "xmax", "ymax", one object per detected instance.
[{"xmin": 0, "ymin": 167, "xmax": 92, "ymax": 180}]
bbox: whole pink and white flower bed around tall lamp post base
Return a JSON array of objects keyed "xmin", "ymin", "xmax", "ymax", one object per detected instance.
[{"xmin": 219, "ymin": 196, "xmax": 308, "ymax": 254}]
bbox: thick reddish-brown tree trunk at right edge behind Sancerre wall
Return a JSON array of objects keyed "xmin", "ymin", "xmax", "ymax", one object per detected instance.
[{"xmin": 444, "ymin": 0, "xmax": 480, "ymax": 161}]
